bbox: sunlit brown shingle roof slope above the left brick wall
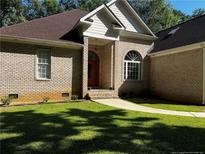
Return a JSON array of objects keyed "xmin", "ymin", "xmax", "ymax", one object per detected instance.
[{"xmin": 0, "ymin": 9, "xmax": 87, "ymax": 41}]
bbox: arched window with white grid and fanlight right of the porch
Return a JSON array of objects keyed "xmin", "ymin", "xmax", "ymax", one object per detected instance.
[{"xmin": 124, "ymin": 51, "xmax": 142, "ymax": 80}]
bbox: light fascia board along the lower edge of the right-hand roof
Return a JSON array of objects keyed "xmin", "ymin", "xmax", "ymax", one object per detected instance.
[{"xmin": 148, "ymin": 42, "xmax": 205, "ymax": 57}]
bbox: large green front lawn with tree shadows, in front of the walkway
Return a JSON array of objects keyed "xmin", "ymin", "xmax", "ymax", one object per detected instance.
[{"xmin": 0, "ymin": 102, "xmax": 205, "ymax": 154}]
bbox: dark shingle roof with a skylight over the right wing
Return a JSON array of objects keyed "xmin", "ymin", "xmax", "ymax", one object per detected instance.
[{"xmin": 151, "ymin": 15, "xmax": 205, "ymax": 53}]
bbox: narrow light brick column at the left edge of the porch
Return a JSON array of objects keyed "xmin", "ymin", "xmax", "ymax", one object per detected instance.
[{"xmin": 82, "ymin": 37, "xmax": 88, "ymax": 98}]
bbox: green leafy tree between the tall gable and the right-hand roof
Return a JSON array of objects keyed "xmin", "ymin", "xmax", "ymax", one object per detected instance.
[{"xmin": 129, "ymin": 0, "xmax": 180, "ymax": 32}]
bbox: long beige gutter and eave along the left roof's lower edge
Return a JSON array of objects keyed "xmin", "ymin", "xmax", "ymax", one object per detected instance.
[{"xmin": 0, "ymin": 35, "xmax": 84, "ymax": 49}]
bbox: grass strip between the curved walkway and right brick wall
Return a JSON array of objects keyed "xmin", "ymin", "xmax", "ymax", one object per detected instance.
[{"xmin": 127, "ymin": 98, "xmax": 205, "ymax": 112}]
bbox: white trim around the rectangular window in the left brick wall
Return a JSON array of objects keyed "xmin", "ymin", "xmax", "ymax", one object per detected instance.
[{"xmin": 35, "ymin": 48, "xmax": 52, "ymax": 81}]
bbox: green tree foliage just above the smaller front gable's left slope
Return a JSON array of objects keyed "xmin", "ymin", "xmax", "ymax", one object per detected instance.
[{"xmin": 78, "ymin": 0, "xmax": 108, "ymax": 11}]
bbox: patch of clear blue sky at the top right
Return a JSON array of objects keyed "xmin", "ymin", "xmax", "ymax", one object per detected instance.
[{"xmin": 170, "ymin": 0, "xmax": 205, "ymax": 15}]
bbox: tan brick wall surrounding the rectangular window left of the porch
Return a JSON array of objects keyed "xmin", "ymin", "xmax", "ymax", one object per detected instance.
[{"xmin": 0, "ymin": 42, "xmax": 82, "ymax": 102}]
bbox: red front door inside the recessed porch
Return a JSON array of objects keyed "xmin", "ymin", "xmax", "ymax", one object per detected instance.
[{"xmin": 88, "ymin": 60, "xmax": 99, "ymax": 88}]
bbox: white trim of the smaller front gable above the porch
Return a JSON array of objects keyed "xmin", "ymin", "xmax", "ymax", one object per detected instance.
[{"xmin": 80, "ymin": 4, "xmax": 125, "ymax": 30}]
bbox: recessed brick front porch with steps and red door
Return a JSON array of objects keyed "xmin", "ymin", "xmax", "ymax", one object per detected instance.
[{"xmin": 84, "ymin": 37, "xmax": 118, "ymax": 98}]
